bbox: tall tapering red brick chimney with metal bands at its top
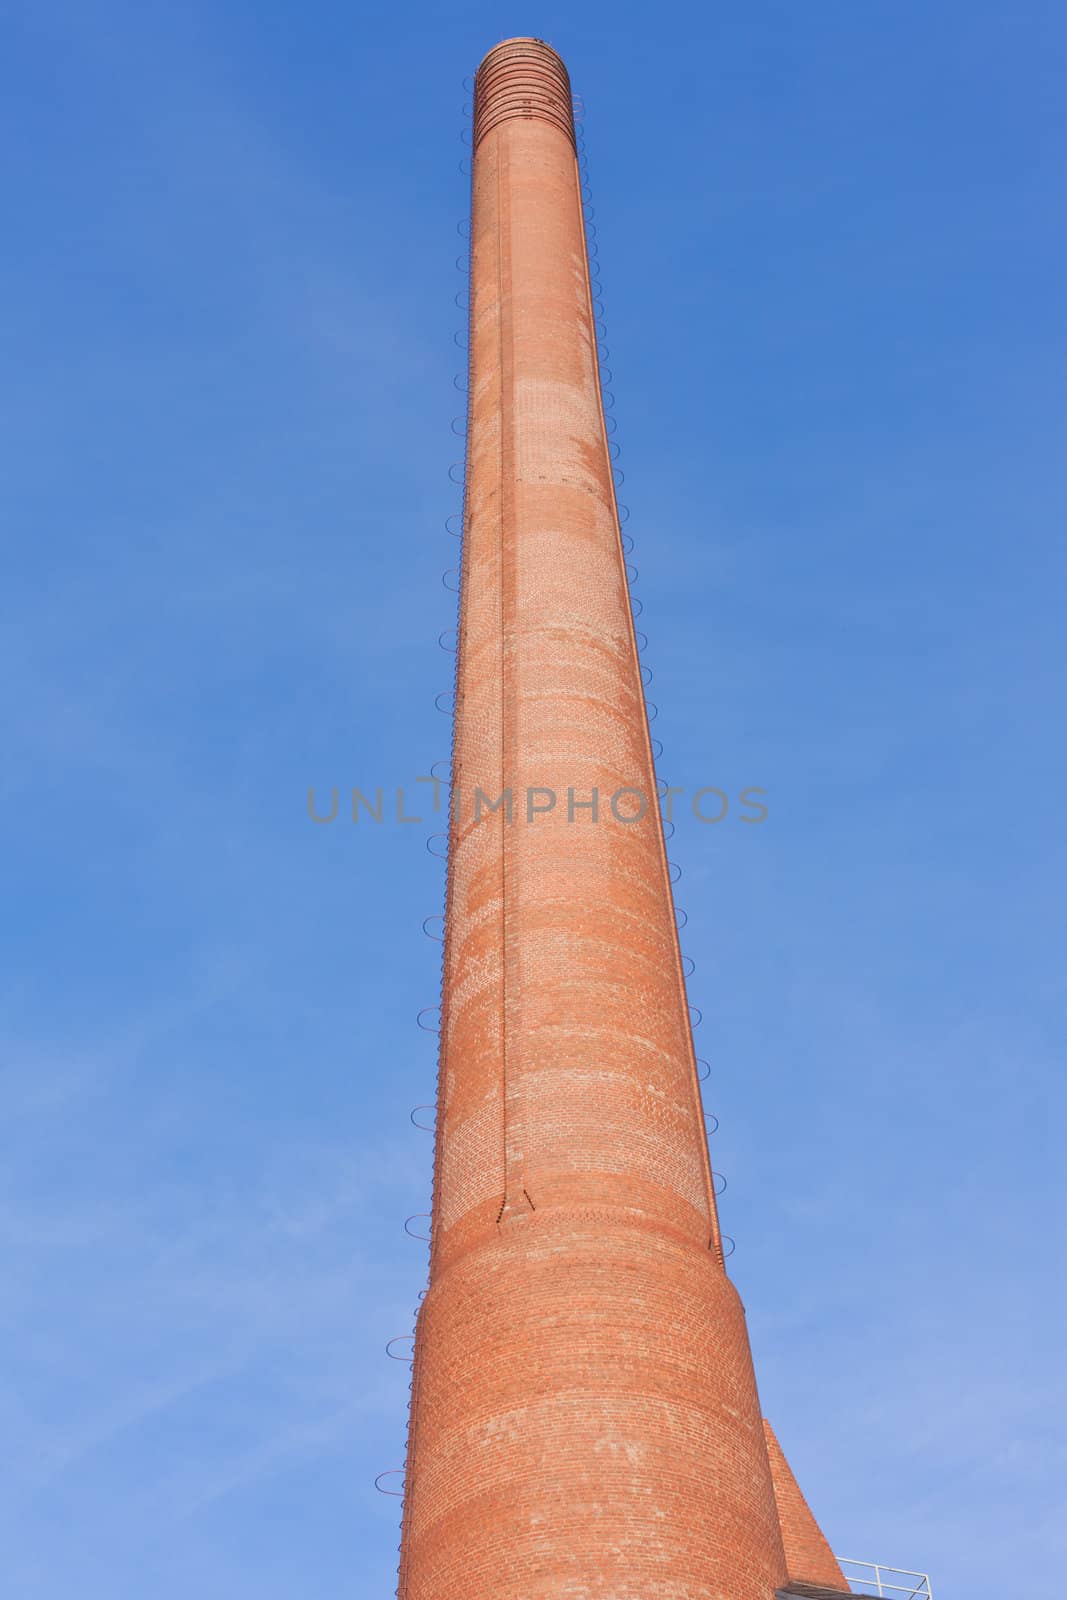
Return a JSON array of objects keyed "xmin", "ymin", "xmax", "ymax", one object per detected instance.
[{"xmin": 398, "ymin": 38, "xmax": 844, "ymax": 1600}]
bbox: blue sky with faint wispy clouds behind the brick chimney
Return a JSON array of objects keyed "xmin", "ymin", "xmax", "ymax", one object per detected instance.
[{"xmin": 0, "ymin": 0, "xmax": 1067, "ymax": 1600}]
